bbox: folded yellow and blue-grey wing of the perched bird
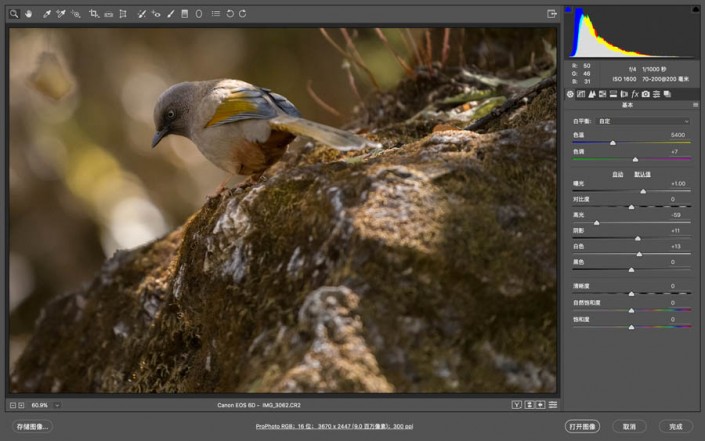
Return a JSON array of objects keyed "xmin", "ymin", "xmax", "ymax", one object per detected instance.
[{"xmin": 206, "ymin": 83, "xmax": 299, "ymax": 127}]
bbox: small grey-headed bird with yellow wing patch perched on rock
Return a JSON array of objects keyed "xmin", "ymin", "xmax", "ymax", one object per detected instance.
[{"xmin": 152, "ymin": 79, "xmax": 376, "ymax": 175}]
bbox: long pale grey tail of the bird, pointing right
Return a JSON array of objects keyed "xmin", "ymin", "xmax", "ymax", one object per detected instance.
[{"xmin": 269, "ymin": 115, "xmax": 379, "ymax": 152}]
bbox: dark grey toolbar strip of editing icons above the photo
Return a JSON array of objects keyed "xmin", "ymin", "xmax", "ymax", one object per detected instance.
[{"xmin": 4, "ymin": 3, "xmax": 561, "ymax": 27}]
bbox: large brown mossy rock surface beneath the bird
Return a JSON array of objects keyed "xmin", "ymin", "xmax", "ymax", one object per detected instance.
[{"xmin": 11, "ymin": 75, "xmax": 557, "ymax": 393}]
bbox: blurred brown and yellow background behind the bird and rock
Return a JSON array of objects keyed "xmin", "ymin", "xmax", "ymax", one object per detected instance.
[{"xmin": 8, "ymin": 28, "xmax": 555, "ymax": 366}]
